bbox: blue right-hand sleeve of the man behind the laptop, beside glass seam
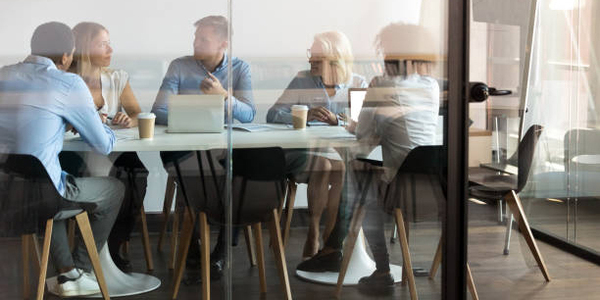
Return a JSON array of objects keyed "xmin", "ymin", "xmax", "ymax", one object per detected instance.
[{"xmin": 225, "ymin": 63, "xmax": 256, "ymax": 123}]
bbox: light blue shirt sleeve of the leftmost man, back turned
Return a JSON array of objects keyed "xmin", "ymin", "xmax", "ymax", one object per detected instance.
[{"xmin": 63, "ymin": 77, "xmax": 116, "ymax": 155}]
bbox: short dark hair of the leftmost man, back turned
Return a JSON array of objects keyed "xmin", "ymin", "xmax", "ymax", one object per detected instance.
[{"xmin": 31, "ymin": 22, "xmax": 75, "ymax": 64}]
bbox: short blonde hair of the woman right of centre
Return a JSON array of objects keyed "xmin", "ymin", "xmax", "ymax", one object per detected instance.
[{"xmin": 314, "ymin": 31, "xmax": 354, "ymax": 84}]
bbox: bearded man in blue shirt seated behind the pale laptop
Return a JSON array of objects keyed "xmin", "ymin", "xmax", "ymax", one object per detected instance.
[{"xmin": 152, "ymin": 16, "xmax": 256, "ymax": 283}]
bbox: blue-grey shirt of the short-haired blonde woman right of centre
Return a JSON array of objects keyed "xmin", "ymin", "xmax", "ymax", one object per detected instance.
[{"xmin": 267, "ymin": 70, "xmax": 367, "ymax": 124}]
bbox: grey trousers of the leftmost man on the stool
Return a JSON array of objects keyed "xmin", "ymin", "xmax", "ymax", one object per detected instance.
[{"xmin": 50, "ymin": 175, "xmax": 125, "ymax": 271}]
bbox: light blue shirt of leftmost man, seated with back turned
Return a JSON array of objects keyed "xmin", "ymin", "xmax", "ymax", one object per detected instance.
[{"xmin": 0, "ymin": 55, "xmax": 115, "ymax": 195}]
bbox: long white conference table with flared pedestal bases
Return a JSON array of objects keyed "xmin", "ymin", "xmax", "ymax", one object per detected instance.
[{"xmin": 56, "ymin": 124, "xmax": 402, "ymax": 297}]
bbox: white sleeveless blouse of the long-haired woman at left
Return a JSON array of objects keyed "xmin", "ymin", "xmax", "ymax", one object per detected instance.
[{"xmin": 99, "ymin": 68, "xmax": 129, "ymax": 118}]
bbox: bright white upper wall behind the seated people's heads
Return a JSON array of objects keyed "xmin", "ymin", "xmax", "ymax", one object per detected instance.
[{"xmin": 0, "ymin": 0, "xmax": 426, "ymax": 56}]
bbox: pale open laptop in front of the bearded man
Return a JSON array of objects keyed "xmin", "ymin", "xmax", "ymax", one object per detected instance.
[{"xmin": 167, "ymin": 95, "xmax": 225, "ymax": 133}]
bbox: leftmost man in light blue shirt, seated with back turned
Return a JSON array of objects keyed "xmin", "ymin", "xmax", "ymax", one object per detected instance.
[{"xmin": 0, "ymin": 22, "xmax": 124, "ymax": 296}]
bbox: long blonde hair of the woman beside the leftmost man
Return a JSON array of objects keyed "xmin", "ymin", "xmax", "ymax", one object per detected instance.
[{"xmin": 69, "ymin": 22, "xmax": 108, "ymax": 80}]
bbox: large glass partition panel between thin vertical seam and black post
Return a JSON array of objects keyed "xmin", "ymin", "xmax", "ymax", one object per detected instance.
[{"xmin": 225, "ymin": 1, "xmax": 448, "ymax": 299}]
